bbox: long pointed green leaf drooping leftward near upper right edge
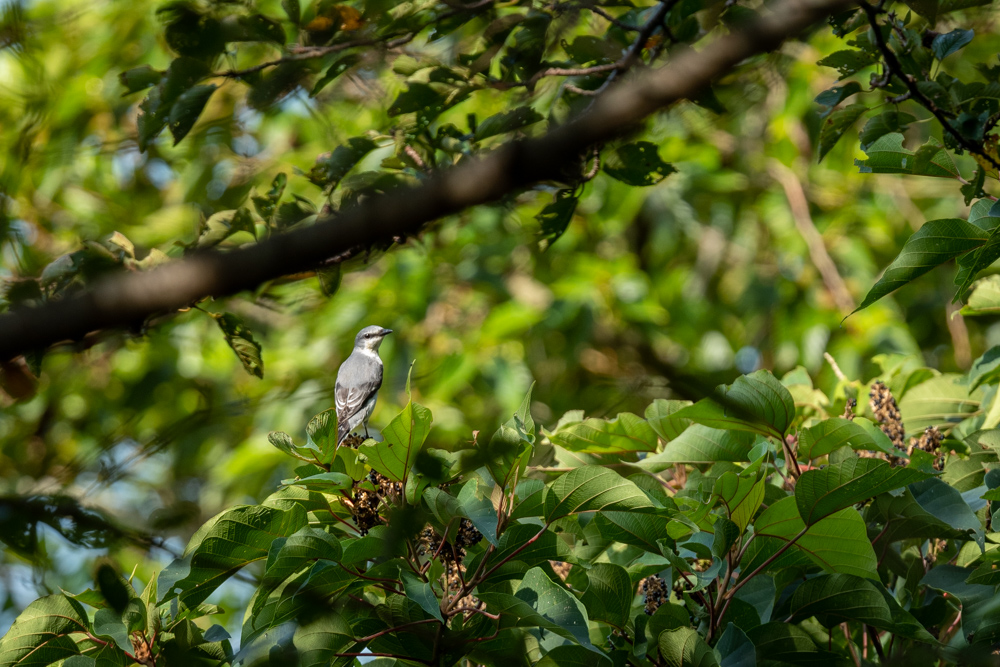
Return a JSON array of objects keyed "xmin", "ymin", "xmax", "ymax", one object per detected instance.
[{"xmin": 854, "ymin": 218, "xmax": 988, "ymax": 313}]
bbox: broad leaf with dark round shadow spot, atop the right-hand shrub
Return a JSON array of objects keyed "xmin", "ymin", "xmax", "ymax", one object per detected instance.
[{"xmin": 671, "ymin": 370, "xmax": 795, "ymax": 444}]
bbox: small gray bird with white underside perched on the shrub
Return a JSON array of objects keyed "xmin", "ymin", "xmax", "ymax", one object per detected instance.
[{"xmin": 334, "ymin": 325, "xmax": 392, "ymax": 445}]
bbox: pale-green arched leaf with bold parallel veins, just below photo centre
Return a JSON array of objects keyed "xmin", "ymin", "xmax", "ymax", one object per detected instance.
[{"xmin": 545, "ymin": 466, "xmax": 655, "ymax": 522}]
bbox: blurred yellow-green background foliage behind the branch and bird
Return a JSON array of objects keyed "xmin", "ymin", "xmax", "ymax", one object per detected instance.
[{"xmin": 0, "ymin": 0, "xmax": 1000, "ymax": 644}]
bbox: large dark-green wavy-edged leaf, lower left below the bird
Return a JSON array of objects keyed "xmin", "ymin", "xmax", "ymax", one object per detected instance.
[{"xmin": 158, "ymin": 505, "xmax": 306, "ymax": 607}]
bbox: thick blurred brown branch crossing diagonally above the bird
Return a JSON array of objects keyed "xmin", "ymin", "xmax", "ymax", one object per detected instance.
[{"xmin": 0, "ymin": 0, "xmax": 850, "ymax": 359}]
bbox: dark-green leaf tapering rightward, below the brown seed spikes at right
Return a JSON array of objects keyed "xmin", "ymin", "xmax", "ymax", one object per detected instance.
[{"xmin": 795, "ymin": 457, "xmax": 930, "ymax": 526}]
